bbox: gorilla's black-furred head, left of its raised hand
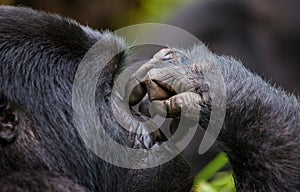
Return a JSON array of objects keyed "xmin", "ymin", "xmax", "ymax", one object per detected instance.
[{"xmin": 0, "ymin": 6, "xmax": 192, "ymax": 191}]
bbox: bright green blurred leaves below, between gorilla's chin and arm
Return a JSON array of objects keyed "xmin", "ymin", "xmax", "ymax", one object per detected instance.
[{"xmin": 193, "ymin": 153, "xmax": 236, "ymax": 192}]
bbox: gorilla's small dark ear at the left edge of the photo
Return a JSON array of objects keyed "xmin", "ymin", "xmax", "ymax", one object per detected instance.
[{"xmin": 0, "ymin": 96, "xmax": 19, "ymax": 145}]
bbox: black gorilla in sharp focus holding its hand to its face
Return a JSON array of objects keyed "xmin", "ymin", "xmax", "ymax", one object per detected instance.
[{"xmin": 0, "ymin": 7, "xmax": 300, "ymax": 191}]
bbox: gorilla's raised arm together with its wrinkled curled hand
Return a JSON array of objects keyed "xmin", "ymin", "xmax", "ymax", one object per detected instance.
[{"xmin": 130, "ymin": 45, "xmax": 300, "ymax": 192}]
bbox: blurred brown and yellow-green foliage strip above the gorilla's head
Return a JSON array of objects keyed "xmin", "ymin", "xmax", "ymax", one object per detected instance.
[{"xmin": 0, "ymin": 0, "xmax": 196, "ymax": 30}]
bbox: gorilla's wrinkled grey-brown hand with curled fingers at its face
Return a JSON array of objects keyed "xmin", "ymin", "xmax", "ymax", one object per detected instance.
[{"xmin": 129, "ymin": 49, "xmax": 211, "ymax": 123}]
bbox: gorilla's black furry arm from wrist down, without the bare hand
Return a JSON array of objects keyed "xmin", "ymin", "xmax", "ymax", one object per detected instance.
[{"xmin": 164, "ymin": 45, "xmax": 300, "ymax": 192}]
